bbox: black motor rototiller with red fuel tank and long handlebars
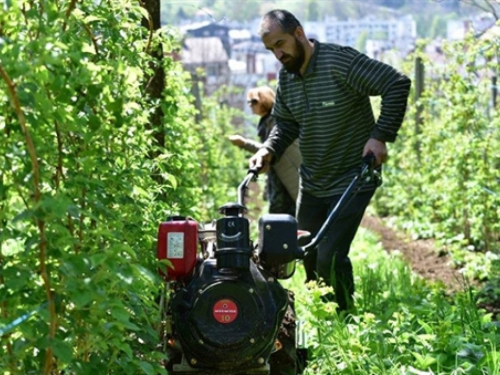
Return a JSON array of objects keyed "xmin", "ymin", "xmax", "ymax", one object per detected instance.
[{"xmin": 157, "ymin": 154, "xmax": 375, "ymax": 375}]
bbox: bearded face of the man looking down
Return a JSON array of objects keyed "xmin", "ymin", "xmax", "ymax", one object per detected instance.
[{"xmin": 262, "ymin": 26, "xmax": 306, "ymax": 73}]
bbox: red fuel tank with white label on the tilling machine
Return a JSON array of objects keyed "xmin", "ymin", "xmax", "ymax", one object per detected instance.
[{"xmin": 157, "ymin": 216, "xmax": 198, "ymax": 280}]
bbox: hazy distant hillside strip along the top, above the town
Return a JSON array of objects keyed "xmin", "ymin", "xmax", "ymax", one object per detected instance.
[{"xmin": 162, "ymin": 0, "xmax": 500, "ymax": 38}]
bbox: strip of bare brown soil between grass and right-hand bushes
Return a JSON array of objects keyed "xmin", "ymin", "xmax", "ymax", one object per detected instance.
[{"xmin": 361, "ymin": 215, "xmax": 463, "ymax": 292}]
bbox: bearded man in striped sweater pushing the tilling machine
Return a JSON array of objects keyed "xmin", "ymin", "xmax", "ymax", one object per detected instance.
[{"xmin": 249, "ymin": 9, "xmax": 411, "ymax": 311}]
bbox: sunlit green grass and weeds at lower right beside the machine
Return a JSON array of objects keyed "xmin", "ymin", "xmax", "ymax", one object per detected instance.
[{"xmin": 283, "ymin": 228, "xmax": 500, "ymax": 375}]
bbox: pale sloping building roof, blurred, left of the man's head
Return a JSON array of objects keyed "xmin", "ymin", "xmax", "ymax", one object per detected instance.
[{"xmin": 181, "ymin": 37, "xmax": 229, "ymax": 64}]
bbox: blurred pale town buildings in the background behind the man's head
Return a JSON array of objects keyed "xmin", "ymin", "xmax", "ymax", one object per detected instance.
[{"xmin": 165, "ymin": 10, "xmax": 500, "ymax": 122}]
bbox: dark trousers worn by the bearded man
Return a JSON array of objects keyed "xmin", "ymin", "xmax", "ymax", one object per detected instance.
[{"xmin": 297, "ymin": 190, "xmax": 375, "ymax": 311}]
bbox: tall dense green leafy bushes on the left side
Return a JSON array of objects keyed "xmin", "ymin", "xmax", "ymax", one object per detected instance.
[{"xmin": 0, "ymin": 0, "xmax": 245, "ymax": 374}]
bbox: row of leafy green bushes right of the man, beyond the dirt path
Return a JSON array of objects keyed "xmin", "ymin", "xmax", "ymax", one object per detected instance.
[{"xmin": 375, "ymin": 31, "xmax": 500, "ymax": 270}]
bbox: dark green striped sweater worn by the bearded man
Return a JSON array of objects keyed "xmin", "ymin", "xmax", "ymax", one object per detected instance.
[{"xmin": 264, "ymin": 41, "xmax": 411, "ymax": 197}]
